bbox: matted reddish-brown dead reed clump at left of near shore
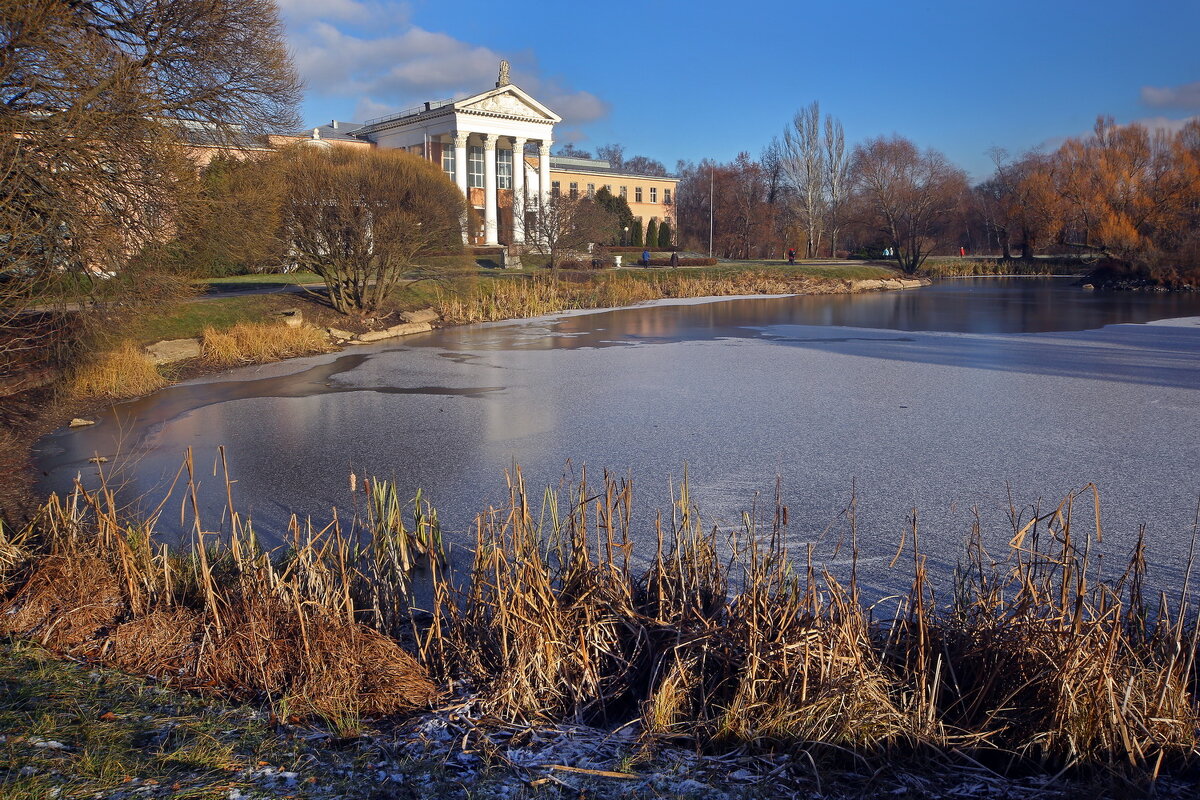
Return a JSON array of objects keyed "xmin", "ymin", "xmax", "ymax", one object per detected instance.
[{"xmin": 0, "ymin": 459, "xmax": 437, "ymax": 718}]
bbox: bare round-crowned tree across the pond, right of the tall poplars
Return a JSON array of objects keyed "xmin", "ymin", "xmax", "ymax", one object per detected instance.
[{"xmin": 851, "ymin": 137, "xmax": 968, "ymax": 275}]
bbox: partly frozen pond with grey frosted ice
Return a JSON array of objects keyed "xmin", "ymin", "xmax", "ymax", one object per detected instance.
[{"xmin": 41, "ymin": 278, "xmax": 1200, "ymax": 591}]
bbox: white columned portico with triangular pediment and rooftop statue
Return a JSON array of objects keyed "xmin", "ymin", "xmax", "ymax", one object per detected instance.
[{"xmin": 350, "ymin": 62, "xmax": 562, "ymax": 245}]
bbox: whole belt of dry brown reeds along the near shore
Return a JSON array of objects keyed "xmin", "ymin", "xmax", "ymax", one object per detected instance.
[{"xmin": 0, "ymin": 462, "xmax": 1200, "ymax": 781}]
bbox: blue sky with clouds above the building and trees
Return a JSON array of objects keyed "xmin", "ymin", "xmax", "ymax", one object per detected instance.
[{"xmin": 280, "ymin": 0, "xmax": 1200, "ymax": 179}]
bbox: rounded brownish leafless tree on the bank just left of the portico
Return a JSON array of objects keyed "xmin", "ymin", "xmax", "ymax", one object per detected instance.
[{"xmin": 281, "ymin": 144, "xmax": 466, "ymax": 313}]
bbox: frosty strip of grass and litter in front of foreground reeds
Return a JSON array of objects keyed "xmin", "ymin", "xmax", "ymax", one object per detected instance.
[{"xmin": 0, "ymin": 643, "xmax": 1194, "ymax": 800}]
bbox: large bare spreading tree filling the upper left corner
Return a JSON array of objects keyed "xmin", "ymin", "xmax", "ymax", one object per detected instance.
[{"xmin": 0, "ymin": 0, "xmax": 300, "ymax": 372}]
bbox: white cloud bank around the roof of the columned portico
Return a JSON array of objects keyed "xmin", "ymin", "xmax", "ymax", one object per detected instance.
[{"xmin": 281, "ymin": 8, "xmax": 610, "ymax": 125}]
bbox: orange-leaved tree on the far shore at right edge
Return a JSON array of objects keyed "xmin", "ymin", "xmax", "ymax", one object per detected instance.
[{"xmin": 1041, "ymin": 118, "xmax": 1200, "ymax": 284}]
